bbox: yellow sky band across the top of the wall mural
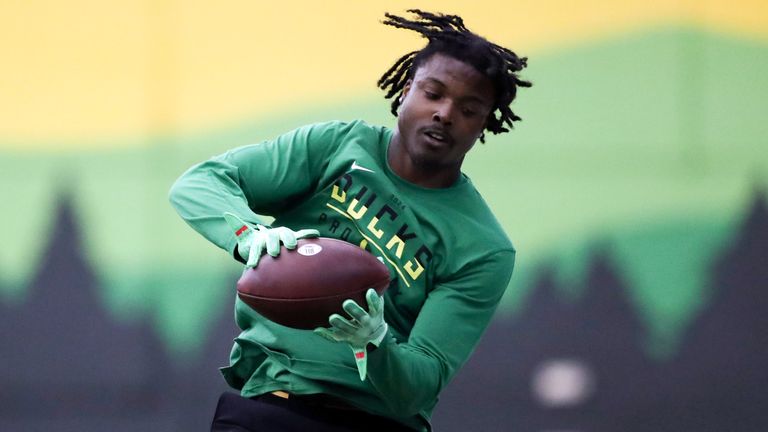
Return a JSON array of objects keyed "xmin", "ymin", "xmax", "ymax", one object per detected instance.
[{"xmin": 0, "ymin": 0, "xmax": 768, "ymax": 150}]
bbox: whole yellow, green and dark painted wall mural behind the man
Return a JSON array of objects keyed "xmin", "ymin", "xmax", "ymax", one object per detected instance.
[{"xmin": 0, "ymin": 0, "xmax": 768, "ymax": 431}]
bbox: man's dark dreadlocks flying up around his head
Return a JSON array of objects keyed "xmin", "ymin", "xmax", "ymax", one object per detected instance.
[{"xmin": 378, "ymin": 9, "xmax": 531, "ymax": 142}]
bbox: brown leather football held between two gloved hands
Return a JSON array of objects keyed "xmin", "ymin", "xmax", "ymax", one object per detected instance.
[{"xmin": 237, "ymin": 237, "xmax": 390, "ymax": 330}]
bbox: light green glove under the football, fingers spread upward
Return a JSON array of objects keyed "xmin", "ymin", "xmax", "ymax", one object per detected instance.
[{"xmin": 315, "ymin": 288, "xmax": 389, "ymax": 381}]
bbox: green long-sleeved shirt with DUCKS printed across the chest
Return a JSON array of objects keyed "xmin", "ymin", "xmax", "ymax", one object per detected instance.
[{"xmin": 170, "ymin": 121, "xmax": 515, "ymax": 430}]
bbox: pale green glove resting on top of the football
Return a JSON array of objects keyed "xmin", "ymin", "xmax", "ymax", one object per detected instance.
[{"xmin": 224, "ymin": 213, "xmax": 320, "ymax": 268}]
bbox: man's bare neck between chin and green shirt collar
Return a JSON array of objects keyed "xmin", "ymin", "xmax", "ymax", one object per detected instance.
[{"xmin": 387, "ymin": 130, "xmax": 461, "ymax": 189}]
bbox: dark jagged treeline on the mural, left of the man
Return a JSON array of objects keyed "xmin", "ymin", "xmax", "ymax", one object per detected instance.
[{"xmin": 0, "ymin": 193, "xmax": 237, "ymax": 432}]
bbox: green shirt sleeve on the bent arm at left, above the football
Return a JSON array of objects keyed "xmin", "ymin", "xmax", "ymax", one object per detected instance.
[{"xmin": 169, "ymin": 123, "xmax": 338, "ymax": 253}]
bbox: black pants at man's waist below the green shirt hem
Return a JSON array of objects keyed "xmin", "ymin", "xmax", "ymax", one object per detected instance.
[{"xmin": 211, "ymin": 392, "xmax": 413, "ymax": 432}]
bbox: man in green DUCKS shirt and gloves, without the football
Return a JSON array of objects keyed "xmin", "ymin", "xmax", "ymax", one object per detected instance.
[{"xmin": 170, "ymin": 10, "xmax": 530, "ymax": 431}]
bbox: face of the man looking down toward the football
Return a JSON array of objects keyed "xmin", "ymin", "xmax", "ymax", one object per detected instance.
[{"xmin": 393, "ymin": 54, "xmax": 494, "ymax": 175}]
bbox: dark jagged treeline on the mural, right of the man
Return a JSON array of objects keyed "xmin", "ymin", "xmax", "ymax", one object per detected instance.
[{"xmin": 435, "ymin": 192, "xmax": 768, "ymax": 432}]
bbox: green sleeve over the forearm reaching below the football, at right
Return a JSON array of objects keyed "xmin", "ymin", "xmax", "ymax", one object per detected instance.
[{"xmin": 368, "ymin": 250, "xmax": 515, "ymax": 416}]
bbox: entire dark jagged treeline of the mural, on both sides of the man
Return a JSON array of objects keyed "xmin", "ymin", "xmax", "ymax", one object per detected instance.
[{"xmin": 0, "ymin": 177, "xmax": 768, "ymax": 432}]
